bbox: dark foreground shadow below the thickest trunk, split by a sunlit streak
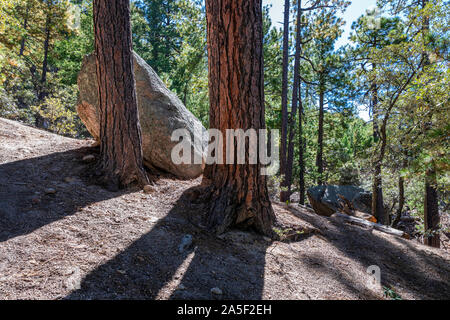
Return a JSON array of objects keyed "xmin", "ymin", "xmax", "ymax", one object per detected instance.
[{"xmin": 66, "ymin": 190, "xmax": 288, "ymax": 300}]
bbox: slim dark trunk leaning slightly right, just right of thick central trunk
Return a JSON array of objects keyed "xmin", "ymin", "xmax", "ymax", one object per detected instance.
[{"xmin": 283, "ymin": 0, "xmax": 302, "ymax": 202}]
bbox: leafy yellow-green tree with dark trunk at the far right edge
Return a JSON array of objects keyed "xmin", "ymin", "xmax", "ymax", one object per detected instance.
[{"xmin": 379, "ymin": 0, "xmax": 450, "ymax": 247}]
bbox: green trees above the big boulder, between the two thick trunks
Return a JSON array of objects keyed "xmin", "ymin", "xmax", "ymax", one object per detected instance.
[{"xmin": 131, "ymin": 0, "xmax": 209, "ymax": 126}]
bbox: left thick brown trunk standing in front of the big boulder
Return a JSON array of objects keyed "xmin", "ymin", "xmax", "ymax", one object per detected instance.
[{"xmin": 94, "ymin": 0, "xmax": 148, "ymax": 188}]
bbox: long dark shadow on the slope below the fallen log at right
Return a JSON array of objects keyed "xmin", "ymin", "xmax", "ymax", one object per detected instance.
[{"xmin": 292, "ymin": 208, "xmax": 450, "ymax": 299}]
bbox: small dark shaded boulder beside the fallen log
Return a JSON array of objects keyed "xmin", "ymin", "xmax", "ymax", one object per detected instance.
[{"xmin": 307, "ymin": 186, "xmax": 372, "ymax": 217}]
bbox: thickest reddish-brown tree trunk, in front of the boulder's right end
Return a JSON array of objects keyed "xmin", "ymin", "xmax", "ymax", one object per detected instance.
[{"xmin": 204, "ymin": 0, "xmax": 275, "ymax": 235}]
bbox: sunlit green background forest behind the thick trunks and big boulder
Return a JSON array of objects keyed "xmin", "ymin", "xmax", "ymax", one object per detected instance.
[{"xmin": 0, "ymin": 0, "xmax": 450, "ymax": 236}]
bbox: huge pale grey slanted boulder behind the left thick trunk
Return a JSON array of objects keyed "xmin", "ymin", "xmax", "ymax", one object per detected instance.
[{"xmin": 77, "ymin": 53, "xmax": 207, "ymax": 179}]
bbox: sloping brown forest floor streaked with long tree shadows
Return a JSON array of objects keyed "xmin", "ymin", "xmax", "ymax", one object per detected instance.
[{"xmin": 0, "ymin": 119, "xmax": 450, "ymax": 300}]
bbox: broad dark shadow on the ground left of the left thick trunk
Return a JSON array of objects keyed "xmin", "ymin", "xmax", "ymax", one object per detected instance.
[{"xmin": 0, "ymin": 147, "xmax": 133, "ymax": 242}]
